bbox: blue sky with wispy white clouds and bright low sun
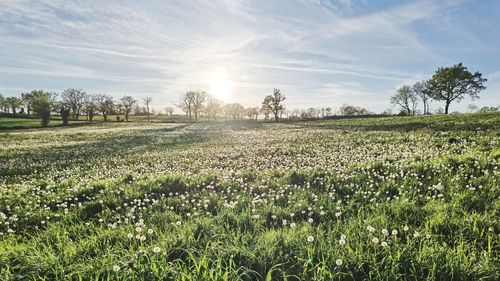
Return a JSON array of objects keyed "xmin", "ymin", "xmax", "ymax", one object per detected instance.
[{"xmin": 0, "ymin": 0, "xmax": 500, "ymax": 112}]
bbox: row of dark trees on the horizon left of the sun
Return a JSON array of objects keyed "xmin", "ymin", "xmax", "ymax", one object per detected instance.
[{"xmin": 0, "ymin": 88, "xmax": 152, "ymax": 127}]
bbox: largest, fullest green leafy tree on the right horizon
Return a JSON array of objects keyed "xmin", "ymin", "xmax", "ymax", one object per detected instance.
[{"xmin": 429, "ymin": 63, "xmax": 487, "ymax": 114}]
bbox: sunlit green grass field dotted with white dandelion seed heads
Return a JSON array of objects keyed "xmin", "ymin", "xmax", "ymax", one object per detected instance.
[{"xmin": 0, "ymin": 113, "xmax": 500, "ymax": 280}]
